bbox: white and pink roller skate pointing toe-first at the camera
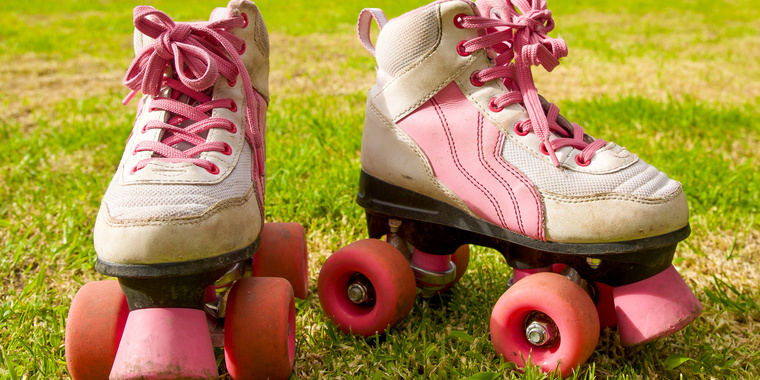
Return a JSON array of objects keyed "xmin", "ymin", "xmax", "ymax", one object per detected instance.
[{"xmin": 65, "ymin": 0, "xmax": 308, "ymax": 379}]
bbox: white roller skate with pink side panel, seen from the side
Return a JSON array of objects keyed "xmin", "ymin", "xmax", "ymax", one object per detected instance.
[{"xmin": 318, "ymin": 0, "xmax": 702, "ymax": 376}]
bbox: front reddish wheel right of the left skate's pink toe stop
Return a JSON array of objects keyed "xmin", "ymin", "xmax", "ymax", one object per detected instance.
[{"xmin": 224, "ymin": 277, "xmax": 296, "ymax": 379}]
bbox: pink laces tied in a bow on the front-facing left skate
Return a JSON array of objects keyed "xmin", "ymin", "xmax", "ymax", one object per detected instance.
[{"xmin": 124, "ymin": 6, "xmax": 263, "ymax": 174}]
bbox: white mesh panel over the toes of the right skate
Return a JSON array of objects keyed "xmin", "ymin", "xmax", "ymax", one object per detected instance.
[{"xmin": 502, "ymin": 139, "xmax": 681, "ymax": 198}]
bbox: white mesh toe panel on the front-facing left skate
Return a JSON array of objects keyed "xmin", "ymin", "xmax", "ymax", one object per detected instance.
[{"xmin": 103, "ymin": 144, "xmax": 253, "ymax": 220}]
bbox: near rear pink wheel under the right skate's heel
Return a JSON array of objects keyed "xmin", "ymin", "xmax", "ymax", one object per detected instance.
[{"xmin": 317, "ymin": 239, "xmax": 416, "ymax": 336}]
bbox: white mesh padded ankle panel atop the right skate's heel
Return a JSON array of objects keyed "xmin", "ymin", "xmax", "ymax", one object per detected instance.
[{"xmin": 376, "ymin": 6, "xmax": 440, "ymax": 76}]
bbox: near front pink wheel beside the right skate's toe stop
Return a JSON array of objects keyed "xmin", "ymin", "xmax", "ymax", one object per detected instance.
[{"xmin": 491, "ymin": 272, "xmax": 599, "ymax": 377}]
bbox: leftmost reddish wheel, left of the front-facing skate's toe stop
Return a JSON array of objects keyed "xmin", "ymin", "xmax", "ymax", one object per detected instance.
[{"xmin": 65, "ymin": 281, "xmax": 129, "ymax": 380}]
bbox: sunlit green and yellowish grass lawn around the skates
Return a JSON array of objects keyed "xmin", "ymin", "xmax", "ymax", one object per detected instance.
[{"xmin": 0, "ymin": 0, "xmax": 760, "ymax": 379}]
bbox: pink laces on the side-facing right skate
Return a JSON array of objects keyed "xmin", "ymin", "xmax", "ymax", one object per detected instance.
[{"xmin": 456, "ymin": 0, "xmax": 607, "ymax": 167}]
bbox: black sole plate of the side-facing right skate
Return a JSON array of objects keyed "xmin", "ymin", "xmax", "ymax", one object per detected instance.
[{"xmin": 356, "ymin": 170, "xmax": 691, "ymax": 286}]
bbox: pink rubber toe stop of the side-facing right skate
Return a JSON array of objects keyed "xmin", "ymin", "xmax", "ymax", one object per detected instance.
[{"xmin": 612, "ymin": 265, "xmax": 702, "ymax": 346}]
